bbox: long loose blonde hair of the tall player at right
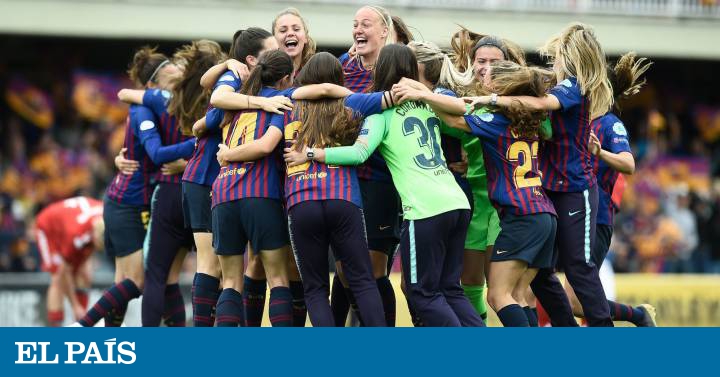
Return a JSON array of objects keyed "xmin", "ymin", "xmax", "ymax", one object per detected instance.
[{"xmin": 539, "ymin": 23, "xmax": 613, "ymax": 119}]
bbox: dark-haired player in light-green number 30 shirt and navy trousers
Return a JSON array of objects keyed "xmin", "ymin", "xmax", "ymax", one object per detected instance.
[{"xmin": 286, "ymin": 44, "xmax": 484, "ymax": 326}]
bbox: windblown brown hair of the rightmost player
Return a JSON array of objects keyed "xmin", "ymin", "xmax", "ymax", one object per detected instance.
[{"xmin": 608, "ymin": 52, "xmax": 653, "ymax": 111}]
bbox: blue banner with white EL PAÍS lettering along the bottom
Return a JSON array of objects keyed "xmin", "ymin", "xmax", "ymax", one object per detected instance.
[{"xmin": 0, "ymin": 328, "xmax": 720, "ymax": 377}]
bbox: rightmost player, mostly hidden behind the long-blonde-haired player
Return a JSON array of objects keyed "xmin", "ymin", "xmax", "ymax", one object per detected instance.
[{"xmin": 565, "ymin": 53, "xmax": 655, "ymax": 327}]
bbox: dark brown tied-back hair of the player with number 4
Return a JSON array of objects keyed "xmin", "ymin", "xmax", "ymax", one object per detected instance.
[{"xmin": 240, "ymin": 50, "xmax": 293, "ymax": 96}]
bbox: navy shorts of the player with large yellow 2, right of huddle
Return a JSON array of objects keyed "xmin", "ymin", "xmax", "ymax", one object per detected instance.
[{"xmin": 491, "ymin": 212, "xmax": 557, "ymax": 268}]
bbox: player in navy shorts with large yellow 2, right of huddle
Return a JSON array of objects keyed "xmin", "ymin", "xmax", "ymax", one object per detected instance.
[{"xmin": 395, "ymin": 62, "xmax": 556, "ymax": 327}]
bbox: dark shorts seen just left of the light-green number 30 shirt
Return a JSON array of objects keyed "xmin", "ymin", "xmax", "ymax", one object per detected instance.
[{"xmin": 360, "ymin": 179, "xmax": 402, "ymax": 257}]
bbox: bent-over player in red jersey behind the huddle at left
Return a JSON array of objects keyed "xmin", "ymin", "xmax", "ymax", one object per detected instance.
[{"xmin": 35, "ymin": 196, "xmax": 105, "ymax": 326}]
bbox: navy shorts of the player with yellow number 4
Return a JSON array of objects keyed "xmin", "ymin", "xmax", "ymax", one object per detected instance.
[{"xmin": 212, "ymin": 198, "xmax": 290, "ymax": 255}]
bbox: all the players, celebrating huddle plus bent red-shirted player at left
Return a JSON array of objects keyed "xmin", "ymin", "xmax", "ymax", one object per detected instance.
[{"xmin": 37, "ymin": 2, "xmax": 655, "ymax": 327}]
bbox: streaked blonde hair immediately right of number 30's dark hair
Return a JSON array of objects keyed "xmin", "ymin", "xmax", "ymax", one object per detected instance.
[{"xmin": 408, "ymin": 41, "xmax": 474, "ymax": 93}]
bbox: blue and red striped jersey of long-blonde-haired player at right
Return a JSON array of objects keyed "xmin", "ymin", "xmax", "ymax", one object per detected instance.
[{"xmin": 540, "ymin": 77, "xmax": 597, "ymax": 192}]
